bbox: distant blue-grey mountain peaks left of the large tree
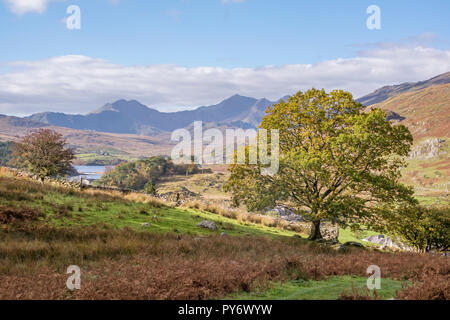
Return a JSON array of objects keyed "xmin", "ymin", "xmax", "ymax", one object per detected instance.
[{"xmin": 24, "ymin": 94, "xmax": 282, "ymax": 135}]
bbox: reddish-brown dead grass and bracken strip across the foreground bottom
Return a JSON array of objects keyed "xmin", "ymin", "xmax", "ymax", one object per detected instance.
[{"xmin": 0, "ymin": 227, "xmax": 450, "ymax": 299}]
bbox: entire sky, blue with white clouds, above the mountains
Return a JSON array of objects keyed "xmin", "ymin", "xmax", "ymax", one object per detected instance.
[{"xmin": 0, "ymin": 0, "xmax": 450, "ymax": 116}]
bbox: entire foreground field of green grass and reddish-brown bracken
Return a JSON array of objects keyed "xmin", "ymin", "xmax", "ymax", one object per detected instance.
[{"xmin": 0, "ymin": 170, "xmax": 450, "ymax": 299}]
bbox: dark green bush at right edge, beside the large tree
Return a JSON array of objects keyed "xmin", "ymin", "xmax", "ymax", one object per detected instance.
[{"xmin": 383, "ymin": 205, "xmax": 450, "ymax": 251}]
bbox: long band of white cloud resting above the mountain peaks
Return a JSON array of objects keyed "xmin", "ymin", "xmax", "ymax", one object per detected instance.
[{"xmin": 0, "ymin": 47, "xmax": 450, "ymax": 114}]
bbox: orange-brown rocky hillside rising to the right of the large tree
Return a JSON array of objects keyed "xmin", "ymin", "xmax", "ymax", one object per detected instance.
[{"xmin": 373, "ymin": 84, "xmax": 450, "ymax": 202}]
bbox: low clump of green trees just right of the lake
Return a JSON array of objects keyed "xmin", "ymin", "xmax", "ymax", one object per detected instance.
[{"xmin": 96, "ymin": 156, "xmax": 199, "ymax": 190}]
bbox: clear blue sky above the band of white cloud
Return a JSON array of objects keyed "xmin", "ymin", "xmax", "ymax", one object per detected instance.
[{"xmin": 0, "ymin": 0, "xmax": 450, "ymax": 67}]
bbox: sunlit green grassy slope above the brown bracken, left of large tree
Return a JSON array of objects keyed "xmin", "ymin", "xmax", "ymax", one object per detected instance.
[{"xmin": 0, "ymin": 177, "xmax": 295, "ymax": 236}]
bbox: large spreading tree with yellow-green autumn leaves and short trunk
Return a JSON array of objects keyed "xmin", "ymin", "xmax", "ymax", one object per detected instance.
[{"xmin": 226, "ymin": 89, "xmax": 414, "ymax": 240}]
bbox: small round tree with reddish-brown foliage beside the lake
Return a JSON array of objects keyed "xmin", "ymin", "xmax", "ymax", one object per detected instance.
[{"xmin": 13, "ymin": 129, "xmax": 75, "ymax": 179}]
